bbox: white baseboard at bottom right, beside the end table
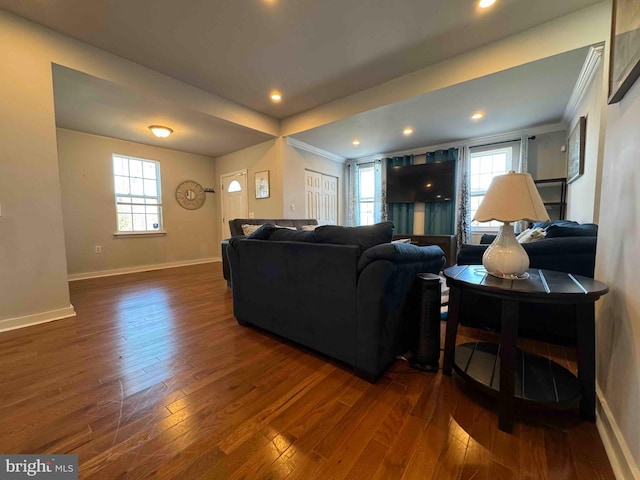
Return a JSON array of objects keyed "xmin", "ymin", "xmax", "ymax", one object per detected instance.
[{"xmin": 596, "ymin": 386, "xmax": 640, "ymax": 480}]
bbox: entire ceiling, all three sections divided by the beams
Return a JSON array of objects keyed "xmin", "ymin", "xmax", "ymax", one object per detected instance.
[{"xmin": 0, "ymin": 0, "xmax": 600, "ymax": 157}]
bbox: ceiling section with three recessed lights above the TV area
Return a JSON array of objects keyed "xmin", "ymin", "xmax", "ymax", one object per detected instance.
[{"xmin": 293, "ymin": 47, "xmax": 589, "ymax": 158}]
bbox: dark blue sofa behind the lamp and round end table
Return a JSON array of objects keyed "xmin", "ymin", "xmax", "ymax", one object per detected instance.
[{"xmin": 457, "ymin": 220, "xmax": 598, "ymax": 345}]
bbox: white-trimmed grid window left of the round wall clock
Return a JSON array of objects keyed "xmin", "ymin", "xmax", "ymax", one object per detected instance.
[{"xmin": 113, "ymin": 154, "xmax": 163, "ymax": 233}]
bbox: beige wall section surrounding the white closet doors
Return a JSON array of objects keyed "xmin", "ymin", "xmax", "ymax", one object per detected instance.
[{"xmin": 283, "ymin": 142, "xmax": 346, "ymax": 225}]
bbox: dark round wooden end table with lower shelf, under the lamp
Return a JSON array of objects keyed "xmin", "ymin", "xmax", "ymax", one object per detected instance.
[{"xmin": 443, "ymin": 265, "xmax": 609, "ymax": 432}]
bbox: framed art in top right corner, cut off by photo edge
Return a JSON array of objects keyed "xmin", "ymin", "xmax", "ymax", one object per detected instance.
[{"xmin": 608, "ymin": 0, "xmax": 640, "ymax": 104}]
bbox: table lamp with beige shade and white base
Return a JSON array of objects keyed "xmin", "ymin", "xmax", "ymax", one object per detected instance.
[{"xmin": 473, "ymin": 170, "xmax": 549, "ymax": 279}]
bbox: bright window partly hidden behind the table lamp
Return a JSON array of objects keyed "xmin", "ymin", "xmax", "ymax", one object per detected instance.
[{"xmin": 469, "ymin": 147, "xmax": 514, "ymax": 230}]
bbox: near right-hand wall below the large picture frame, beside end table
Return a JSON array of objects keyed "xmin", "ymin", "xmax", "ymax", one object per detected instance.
[{"xmin": 596, "ymin": 77, "xmax": 640, "ymax": 478}]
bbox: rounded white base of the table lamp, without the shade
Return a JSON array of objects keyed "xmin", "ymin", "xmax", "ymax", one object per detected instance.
[{"xmin": 482, "ymin": 223, "xmax": 529, "ymax": 280}]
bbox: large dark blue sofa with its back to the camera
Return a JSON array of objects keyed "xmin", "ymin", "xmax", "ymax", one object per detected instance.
[{"xmin": 227, "ymin": 222, "xmax": 444, "ymax": 382}]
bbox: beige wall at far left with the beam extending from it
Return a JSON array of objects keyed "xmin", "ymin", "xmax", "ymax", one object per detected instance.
[{"xmin": 0, "ymin": 11, "xmax": 272, "ymax": 330}]
